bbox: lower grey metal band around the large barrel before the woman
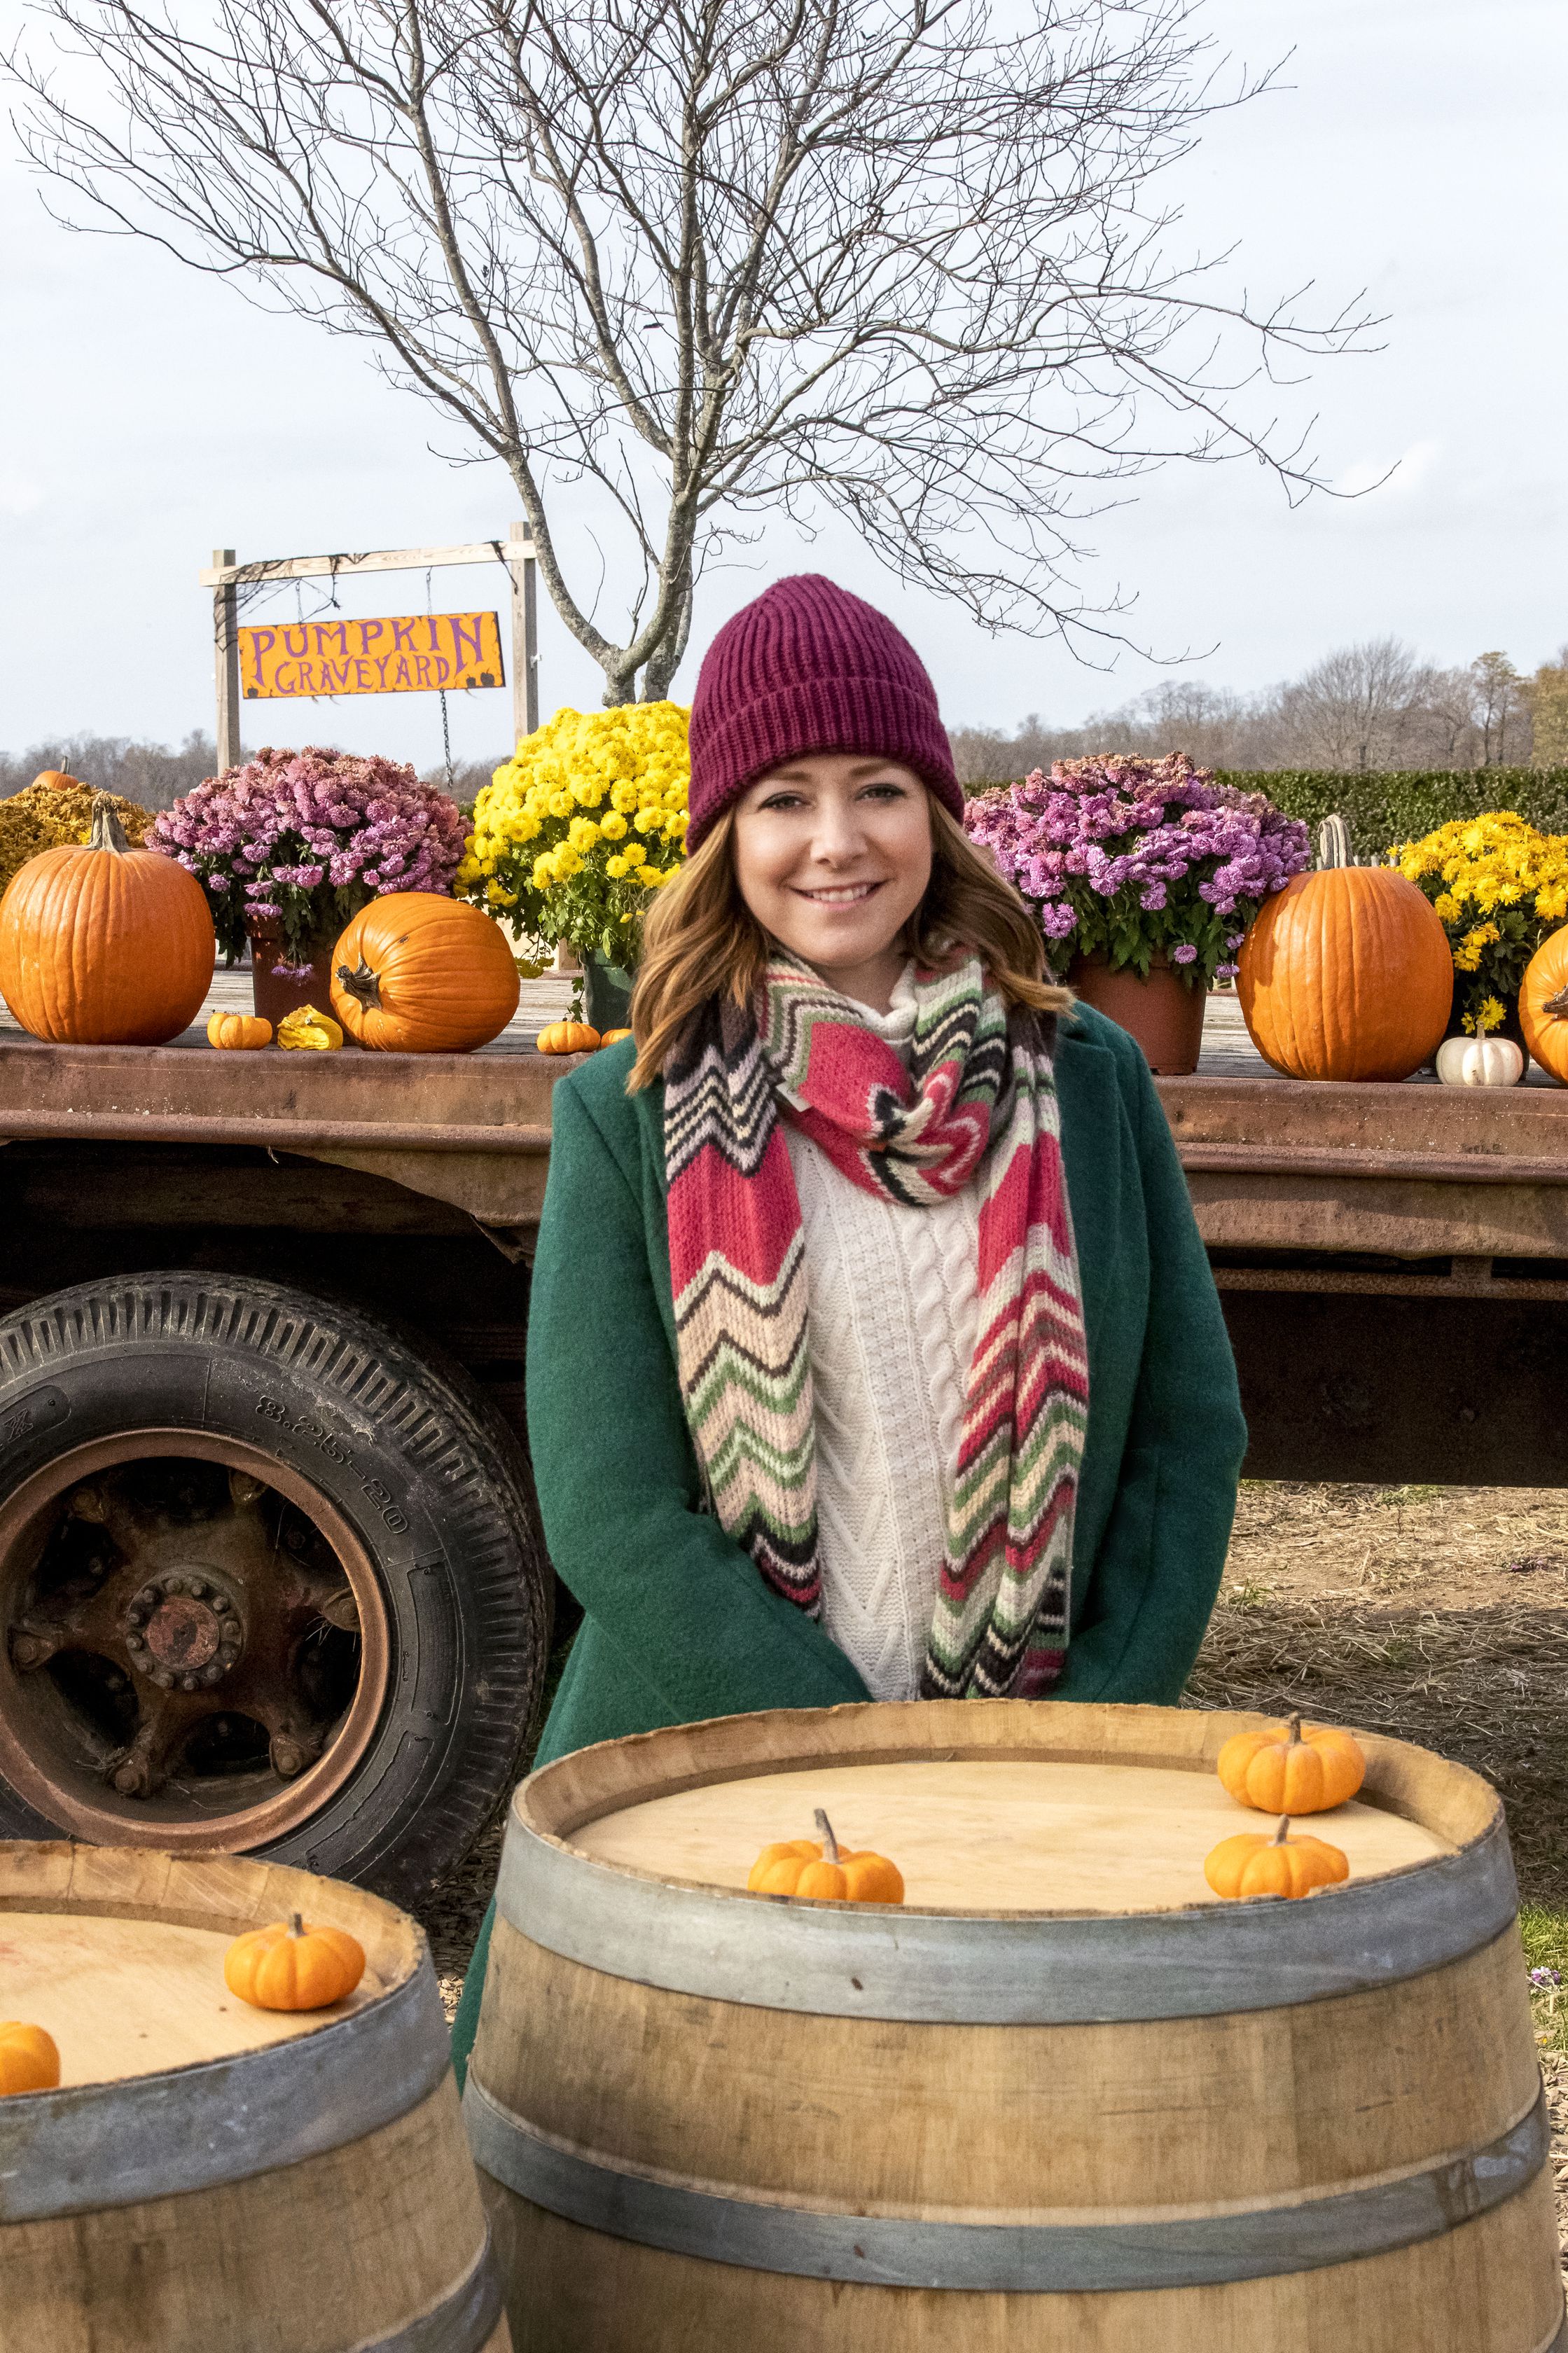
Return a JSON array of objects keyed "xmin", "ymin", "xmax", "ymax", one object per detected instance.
[{"xmin": 464, "ymin": 2071, "xmax": 1549, "ymax": 2296}]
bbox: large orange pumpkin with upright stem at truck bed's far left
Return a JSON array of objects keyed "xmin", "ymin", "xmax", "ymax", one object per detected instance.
[{"xmin": 0, "ymin": 796, "xmax": 216, "ymax": 1045}]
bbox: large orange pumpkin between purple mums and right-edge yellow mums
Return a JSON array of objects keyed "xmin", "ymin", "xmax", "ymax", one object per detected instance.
[{"xmin": 1236, "ymin": 866, "xmax": 1452, "ymax": 1078}]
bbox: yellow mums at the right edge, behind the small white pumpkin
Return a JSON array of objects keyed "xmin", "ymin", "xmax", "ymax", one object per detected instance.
[{"xmin": 1389, "ymin": 810, "xmax": 1568, "ymax": 1035}]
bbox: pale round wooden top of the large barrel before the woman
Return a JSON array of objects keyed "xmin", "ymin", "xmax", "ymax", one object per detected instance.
[{"xmin": 570, "ymin": 1758, "xmax": 1452, "ymax": 1913}]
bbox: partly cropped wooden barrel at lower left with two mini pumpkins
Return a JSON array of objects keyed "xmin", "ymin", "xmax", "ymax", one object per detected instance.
[{"xmin": 0, "ymin": 1845, "xmax": 511, "ymax": 2353}]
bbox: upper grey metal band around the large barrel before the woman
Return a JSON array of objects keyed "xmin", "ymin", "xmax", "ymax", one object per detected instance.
[{"xmin": 497, "ymin": 1812, "xmax": 1518, "ymax": 2026}]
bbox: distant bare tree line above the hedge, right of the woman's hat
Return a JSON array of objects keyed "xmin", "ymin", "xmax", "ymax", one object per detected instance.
[{"xmin": 951, "ymin": 638, "xmax": 1568, "ymax": 784}]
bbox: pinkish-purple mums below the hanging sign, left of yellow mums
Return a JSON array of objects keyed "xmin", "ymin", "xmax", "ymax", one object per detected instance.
[{"xmin": 148, "ymin": 744, "xmax": 464, "ymax": 972}]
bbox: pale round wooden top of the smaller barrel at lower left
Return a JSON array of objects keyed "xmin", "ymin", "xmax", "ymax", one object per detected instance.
[{"xmin": 0, "ymin": 1910, "xmax": 386, "ymax": 2085}]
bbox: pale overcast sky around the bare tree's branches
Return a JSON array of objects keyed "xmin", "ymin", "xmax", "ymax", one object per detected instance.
[{"xmin": 0, "ymin": 0, "xmax": 1568, "ymax": 763}]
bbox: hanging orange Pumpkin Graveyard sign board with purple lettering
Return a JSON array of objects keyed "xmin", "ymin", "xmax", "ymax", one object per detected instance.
[{"xmin": 240, "ymin": 612, "xmax": 506, "ymax": 701}]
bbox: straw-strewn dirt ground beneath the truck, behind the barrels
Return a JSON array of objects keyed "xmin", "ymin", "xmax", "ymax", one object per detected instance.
[{"xmin": 424, "ymin": 1483, "xmax": 1568, "ymax": 2268}]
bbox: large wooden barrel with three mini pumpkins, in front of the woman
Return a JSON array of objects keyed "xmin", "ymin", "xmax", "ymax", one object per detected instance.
[{"xmin": 464, "ymin": 1701, "xmax": 1568, "ymax": 2353}]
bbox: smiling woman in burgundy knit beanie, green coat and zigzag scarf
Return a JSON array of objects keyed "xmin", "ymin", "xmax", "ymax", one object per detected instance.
[{"xmin": 457, "ymin": 576, "xmax": 1245, "ymax": 2066}]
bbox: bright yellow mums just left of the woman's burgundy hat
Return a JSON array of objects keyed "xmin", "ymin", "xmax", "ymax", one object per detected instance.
[{"xmin": 457, "ymin": 704, "xmax": 692, "ymax": 969}]
